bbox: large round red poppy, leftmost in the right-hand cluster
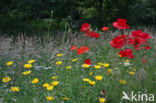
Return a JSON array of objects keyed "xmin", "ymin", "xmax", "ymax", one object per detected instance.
[{"xmin": 110, "ymin": 34, "xmax": 127, "ymax": 49}]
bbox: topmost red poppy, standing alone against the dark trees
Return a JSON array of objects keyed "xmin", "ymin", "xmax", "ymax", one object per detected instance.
[{"xmin": 113, "ymin": 18, "xmax": 130, "ymax": 29}]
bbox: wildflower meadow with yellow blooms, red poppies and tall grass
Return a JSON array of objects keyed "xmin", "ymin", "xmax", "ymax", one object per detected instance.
[{"xmin": 0, "ymin": 18, "xmax": 156, "ymax": 103}]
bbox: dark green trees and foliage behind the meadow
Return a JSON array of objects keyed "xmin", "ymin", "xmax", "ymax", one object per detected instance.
[{"xmin": 0, "ymin": 0, "xmax": 156, "ymax": 32}]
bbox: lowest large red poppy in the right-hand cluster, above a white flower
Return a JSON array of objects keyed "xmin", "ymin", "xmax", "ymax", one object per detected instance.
[{"xmin": 118, "ymin": 49, "xmax": 134, "ymax": 59}]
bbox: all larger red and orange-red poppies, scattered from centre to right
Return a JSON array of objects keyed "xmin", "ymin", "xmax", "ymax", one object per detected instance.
[{"xmin": 70, "ymin": 18, "xmax": 151, "ymax": 59}]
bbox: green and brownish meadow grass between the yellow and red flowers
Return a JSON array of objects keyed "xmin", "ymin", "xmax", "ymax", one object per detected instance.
[{"xmin": 0, "ymin": 31, "xmax": 156, "ymax": 103}]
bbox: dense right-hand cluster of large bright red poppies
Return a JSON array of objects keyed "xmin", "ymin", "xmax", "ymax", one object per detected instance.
[{"xmin": 110, "ymin": 18, "xmax": 151, "ymax": 59}]
